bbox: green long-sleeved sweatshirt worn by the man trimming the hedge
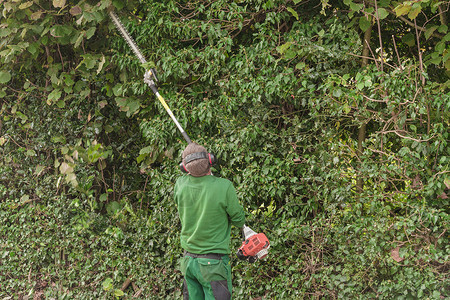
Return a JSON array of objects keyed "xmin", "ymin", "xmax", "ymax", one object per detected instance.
[{"xmin": 174, "ymin": 175, "xmax": 245, "ymax": 254}]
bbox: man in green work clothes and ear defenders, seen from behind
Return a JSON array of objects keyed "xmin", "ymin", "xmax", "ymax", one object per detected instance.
[{"xmin": 174, "ymin": 143, "xmax": 245, "ymax": 300}]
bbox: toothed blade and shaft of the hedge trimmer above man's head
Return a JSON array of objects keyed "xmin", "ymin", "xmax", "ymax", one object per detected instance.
[{"xmin": 109, "ymin": 9, "xmax": 192, "ymax": 144}]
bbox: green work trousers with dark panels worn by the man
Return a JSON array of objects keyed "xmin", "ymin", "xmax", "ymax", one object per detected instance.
[{"xmin": 181, "ymin": 255, "xmax": 231, "ymax": 300}]
